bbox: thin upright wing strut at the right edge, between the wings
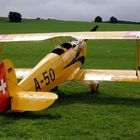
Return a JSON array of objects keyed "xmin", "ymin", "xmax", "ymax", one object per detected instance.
[{"xmin": 136, "ymin": 40, "xmax": 140, "ymax": 79}]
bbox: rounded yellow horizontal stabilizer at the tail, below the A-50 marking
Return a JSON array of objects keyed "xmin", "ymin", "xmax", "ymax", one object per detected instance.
[{"xmin": 11, "ymin": 91, "xmax": 58, "ymax": 111}]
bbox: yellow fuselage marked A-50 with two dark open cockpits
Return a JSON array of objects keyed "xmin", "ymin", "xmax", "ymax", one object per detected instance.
[{"xmin": 19, "ymin": 41, "xmax": 86, "ymax": 92}]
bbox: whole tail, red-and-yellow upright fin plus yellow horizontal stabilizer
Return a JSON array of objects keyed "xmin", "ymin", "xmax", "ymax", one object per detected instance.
[{"xmin": 0, "ymin": 60, "xmax": 58, "ymax": 112}]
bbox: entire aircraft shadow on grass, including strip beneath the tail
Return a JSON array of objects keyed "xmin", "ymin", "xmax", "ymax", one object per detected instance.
[{"xmin": 2, "ymin": 91, "xmax": 140, "ymax": 121}]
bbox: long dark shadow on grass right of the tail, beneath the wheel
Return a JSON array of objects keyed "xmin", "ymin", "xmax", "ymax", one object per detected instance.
[{"xmin": 55, "ymin": 92, "xmax": 140, "ymax": 107}]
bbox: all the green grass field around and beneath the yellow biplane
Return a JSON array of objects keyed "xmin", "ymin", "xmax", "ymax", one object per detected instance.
[{"xmin": 0, "ymin": 18, "xmax": 140, "ymax": 140}]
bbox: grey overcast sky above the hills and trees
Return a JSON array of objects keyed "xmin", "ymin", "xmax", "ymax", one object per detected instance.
[{"xmin": 0, "ymin": 0, "xmax": 140, "ymax": 21}]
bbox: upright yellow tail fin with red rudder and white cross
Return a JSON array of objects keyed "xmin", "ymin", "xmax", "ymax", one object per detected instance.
[{"xmin": 0, "ymin": 60, "xmax": 17, "ymax": 112}]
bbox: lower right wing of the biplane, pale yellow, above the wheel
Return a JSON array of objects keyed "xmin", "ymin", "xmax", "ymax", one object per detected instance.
[{"xmin": 73, "ymin": 69, "xmax": 140, "ymax": 82}]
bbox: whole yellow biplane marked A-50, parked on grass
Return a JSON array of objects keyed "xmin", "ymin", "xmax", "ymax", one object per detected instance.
[{"xmin": 0, "ymin": 27, "xmax": 140, "ymax": 112}]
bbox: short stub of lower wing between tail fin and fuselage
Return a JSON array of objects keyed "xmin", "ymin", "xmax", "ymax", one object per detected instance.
[{"xmin": 15, "ymin": 69, "xmax": 32, "ymax": 79}]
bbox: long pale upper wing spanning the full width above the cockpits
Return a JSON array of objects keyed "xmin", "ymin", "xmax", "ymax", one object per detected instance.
[{"xmin": 0, "ymin": 31, "xmax": 140, "ymax": 42}]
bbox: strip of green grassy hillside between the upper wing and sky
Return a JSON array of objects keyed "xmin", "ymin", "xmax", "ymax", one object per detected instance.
[{"xmin": 0, "ymin": 17, "xmax": 140, "ymax": 34}]
